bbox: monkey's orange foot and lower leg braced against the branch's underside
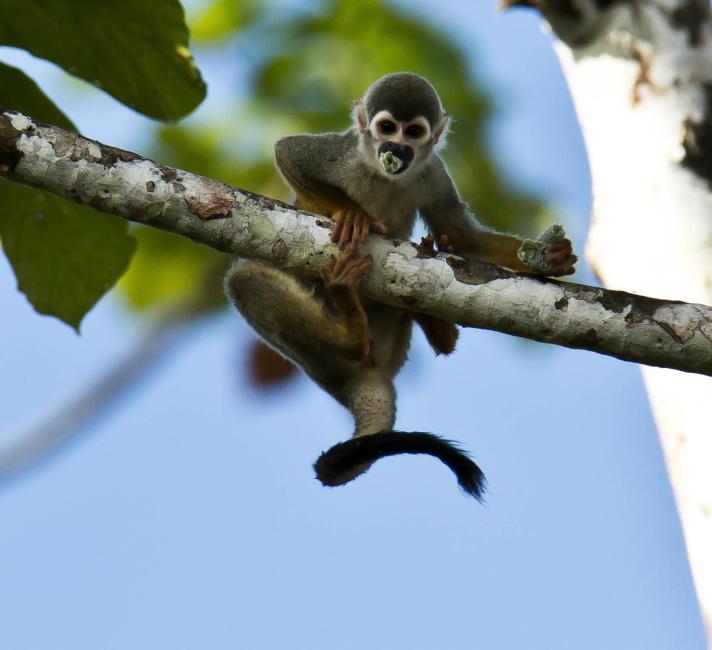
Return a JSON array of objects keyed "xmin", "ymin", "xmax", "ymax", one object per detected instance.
[{"xmin": 321, "ymin": 248, "xmax": 373, "ymax": 363}]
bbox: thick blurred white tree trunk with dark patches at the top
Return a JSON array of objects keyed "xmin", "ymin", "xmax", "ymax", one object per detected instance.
[{"xmin": 510, "ymin": 0, "xmax": 712, "ymax": 638}]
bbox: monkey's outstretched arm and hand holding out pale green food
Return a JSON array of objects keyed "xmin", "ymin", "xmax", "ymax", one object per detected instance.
[{"xmin": 420, "ymin": 159, "xmax": 576, "ymax": 276}]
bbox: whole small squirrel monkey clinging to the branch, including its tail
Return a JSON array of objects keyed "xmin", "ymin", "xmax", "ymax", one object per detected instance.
[{"xmin": 225, "ymin": 73, "xmax": 576, "ymax": 499}]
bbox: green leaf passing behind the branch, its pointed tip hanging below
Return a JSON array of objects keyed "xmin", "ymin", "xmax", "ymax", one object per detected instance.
[{"xmin": 0, "ymin": 63, "xmax": 135, "ymax": 329}]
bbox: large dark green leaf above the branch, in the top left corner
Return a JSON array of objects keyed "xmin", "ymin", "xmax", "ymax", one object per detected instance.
[{"xmin": 0, "ymin": 0, "xmax": 205, "ymax": 120}]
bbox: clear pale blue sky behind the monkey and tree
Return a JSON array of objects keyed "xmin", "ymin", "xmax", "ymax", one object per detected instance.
[{"xmin": 0, "ymin": 0, "xmax": 704, "ymax": 650}]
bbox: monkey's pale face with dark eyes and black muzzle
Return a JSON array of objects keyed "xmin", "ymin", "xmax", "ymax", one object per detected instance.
[{"xmin": 361, "ymin": 110, "xmax": 434, "ymax": 178}]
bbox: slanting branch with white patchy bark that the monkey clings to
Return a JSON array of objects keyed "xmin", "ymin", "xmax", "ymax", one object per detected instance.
[{"xmin": 0, "ymin": 111, "xmax": 712, "ymax": 375}]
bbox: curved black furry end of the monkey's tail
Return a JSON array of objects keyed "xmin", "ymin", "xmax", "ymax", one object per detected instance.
[{"xmin": 314, "ymin": 431, "xmax": 486, "ymax": 502}]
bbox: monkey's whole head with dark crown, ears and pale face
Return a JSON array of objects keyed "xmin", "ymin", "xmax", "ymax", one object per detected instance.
[{"xmin": 354, "ymin": 72, "xmax": 449, "ymax": 179}]
